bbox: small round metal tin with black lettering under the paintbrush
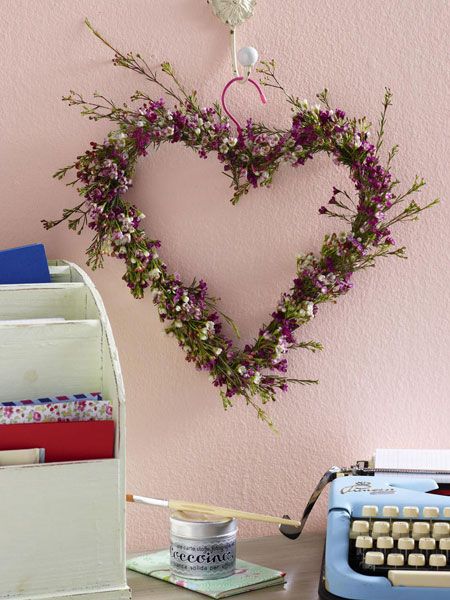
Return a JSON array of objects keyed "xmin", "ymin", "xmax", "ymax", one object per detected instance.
[{"xmin": 170, "ymin": 511, "xmax": 237, "ymax": 579}]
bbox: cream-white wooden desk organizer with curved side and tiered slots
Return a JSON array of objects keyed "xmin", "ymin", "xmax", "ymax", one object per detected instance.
[{"xmin": 0, "ymin": 261, "xmax": 130, "ymax": 600}]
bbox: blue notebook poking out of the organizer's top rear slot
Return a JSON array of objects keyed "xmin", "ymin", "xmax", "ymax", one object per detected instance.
[{"xmin": 0, "ymin": 244, "xmax": 50, "ymax": 285}]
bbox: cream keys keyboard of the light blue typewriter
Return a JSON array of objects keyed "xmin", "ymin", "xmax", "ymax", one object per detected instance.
[{"xmin": 349, "ymin": 506, "xmax": 450, "ymax": 588}]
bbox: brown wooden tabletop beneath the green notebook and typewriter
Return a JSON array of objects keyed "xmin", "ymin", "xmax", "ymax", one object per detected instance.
[{"xmin": 128, "ymin": 533, "xmax": 323, "ymax": 600}]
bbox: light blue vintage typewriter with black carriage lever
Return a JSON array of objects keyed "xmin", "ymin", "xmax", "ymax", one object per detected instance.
[{"xmin": 280, "ymin": 452, "xmax": 450, "ymax": 600}]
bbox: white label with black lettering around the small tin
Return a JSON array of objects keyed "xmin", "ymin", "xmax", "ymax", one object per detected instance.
[{"xmin": 170, "ymin": 538, "xmax": 236, "ymax": 579}]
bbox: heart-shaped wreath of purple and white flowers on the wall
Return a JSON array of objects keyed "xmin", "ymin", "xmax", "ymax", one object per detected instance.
[{"xmin": 44, "ymin": 24, "xmax": 437, "ymax": 425}]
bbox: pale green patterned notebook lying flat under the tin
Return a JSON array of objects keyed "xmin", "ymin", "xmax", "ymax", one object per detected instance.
[{"xmin": 127, "ymin": 550, "xmax": 286, "ymax": 598}]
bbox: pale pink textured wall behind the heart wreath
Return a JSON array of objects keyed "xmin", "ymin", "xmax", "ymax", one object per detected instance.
[{"xmin": 0, "ymin": 0, "xmax": 450, "ymax": 549}]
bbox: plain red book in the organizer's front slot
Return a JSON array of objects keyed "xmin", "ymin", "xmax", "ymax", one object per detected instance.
[{"xmin": 0, "ymin": 421, "xmax": 114, "ymax": 463}]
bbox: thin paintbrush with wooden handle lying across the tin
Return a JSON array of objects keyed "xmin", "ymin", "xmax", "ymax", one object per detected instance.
[{"xmin": 126, "ymin": 494, "xmax": 300, "ymax": 527}]
